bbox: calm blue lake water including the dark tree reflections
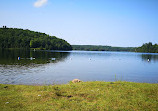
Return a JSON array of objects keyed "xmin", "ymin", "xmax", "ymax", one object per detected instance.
[{"xmin": 0, "ymin": 50, "xmax": 158, "ymax": 85}]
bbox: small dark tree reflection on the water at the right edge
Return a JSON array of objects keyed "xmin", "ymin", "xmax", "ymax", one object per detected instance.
[{"xmin": 141, "ymin": 54, "xmax": 158, "ymax": 62}]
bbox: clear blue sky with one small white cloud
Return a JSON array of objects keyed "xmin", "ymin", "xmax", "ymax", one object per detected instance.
[{"xmin": 0, "ymin": 0, "xmax": 158, "ymax": 47}]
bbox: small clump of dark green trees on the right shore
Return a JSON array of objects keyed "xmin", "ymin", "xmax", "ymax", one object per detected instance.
[{"xmin": 136, "ymin": 42, "xmax": 158, "ymax": 53}]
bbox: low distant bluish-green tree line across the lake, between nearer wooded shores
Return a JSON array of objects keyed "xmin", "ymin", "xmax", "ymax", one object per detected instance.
[{"xmin": 72, "ymin": 45, "xmax": 135, "ymax": 51}]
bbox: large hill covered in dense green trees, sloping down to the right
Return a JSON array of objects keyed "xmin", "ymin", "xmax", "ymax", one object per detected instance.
[{"xmin": 0, "ymin": 26, "xmax": 72, "ymax": 50}]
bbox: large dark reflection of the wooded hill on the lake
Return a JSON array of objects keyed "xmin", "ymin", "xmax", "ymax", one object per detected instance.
[{"xmin": 0, "ymin": 49, "xmax": 69, "ymax": 65}]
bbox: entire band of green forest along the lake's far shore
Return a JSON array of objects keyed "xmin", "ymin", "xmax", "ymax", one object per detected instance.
[{"xmin": 0, "ymin": 26, "xmax": 158, "ymax": 53}]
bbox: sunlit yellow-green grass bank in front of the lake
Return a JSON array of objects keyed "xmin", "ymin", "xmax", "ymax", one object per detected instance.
[{"xmin": 0, "ymin": 81, "xmax": 158, "ymax": 111}]
